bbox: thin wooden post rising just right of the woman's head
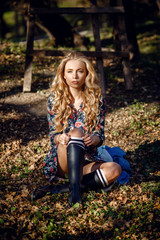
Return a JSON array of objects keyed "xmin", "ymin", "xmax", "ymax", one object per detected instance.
[{"xmin": 91, "ymin": 0, "xmax": 105, "ymax": 95}]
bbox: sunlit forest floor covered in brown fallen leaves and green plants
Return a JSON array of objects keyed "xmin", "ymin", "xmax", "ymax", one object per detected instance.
[{"xmin": 0, "ymin": 38, "xmax": 160, "ymax": 240}]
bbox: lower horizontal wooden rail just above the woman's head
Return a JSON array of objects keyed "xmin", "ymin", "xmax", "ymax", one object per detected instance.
[{"xmin": 28, "ymin": 50, "xmax": 129, "ymax": 59}]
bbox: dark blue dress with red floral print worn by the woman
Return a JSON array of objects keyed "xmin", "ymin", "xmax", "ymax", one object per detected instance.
[{"xmin": 43, "ymin": 95, "xmax": 106, "ymax": 182}]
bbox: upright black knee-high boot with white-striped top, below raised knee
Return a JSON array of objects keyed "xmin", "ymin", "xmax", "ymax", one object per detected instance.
[{"xmin": 67, "ymin": 138, "xmax": 85, "ymax": 206}]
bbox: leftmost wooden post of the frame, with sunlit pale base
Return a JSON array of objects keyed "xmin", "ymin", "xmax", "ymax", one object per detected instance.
[{"xmin": 23, "ymin": 7, "xmax": 35, "ymax": 92}]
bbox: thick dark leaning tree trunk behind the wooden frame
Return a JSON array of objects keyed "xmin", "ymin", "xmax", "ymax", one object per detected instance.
[{"xmin": 7, "ymin": 0, "xmax": 89, "ymax": 48}]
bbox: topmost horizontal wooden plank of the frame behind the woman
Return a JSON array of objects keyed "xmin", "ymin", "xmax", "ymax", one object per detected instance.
[{"xmin": 30, "ymin": 6, "xmax": 124, "ymax": 14}]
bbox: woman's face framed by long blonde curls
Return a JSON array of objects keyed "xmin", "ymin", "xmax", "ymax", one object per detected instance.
[{"xmin": 64, "ymin": 60, "xmax": 87, "ymax": 90}]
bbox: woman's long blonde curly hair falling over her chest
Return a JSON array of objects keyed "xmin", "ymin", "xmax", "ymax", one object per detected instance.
[{"xmin": 52, "ymin": 52, "xmax": 102, "ymax": 133}]
